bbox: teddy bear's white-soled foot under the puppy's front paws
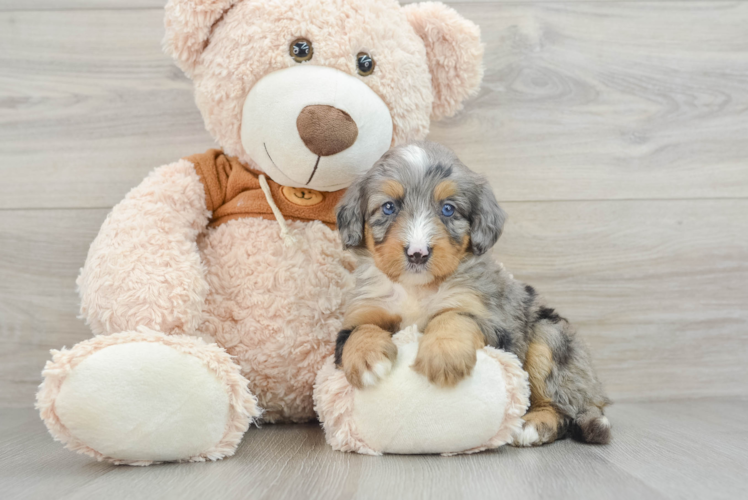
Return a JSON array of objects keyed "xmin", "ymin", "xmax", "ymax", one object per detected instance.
[{"xmin": 314, "ymin": 326, "xmax": 530, "ymax": 455}]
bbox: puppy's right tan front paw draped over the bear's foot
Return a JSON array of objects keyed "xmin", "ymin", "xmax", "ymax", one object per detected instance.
[{"xmin": 413, "ymin": 334, "xmax": 477, "ymax": 387}]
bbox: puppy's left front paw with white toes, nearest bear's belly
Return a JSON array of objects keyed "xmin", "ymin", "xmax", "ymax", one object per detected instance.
[{"xmin": 341, "ymin": 325, "xmax": 397, "ymax": 389}]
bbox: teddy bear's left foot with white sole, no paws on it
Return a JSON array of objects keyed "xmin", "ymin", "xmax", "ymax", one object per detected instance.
[{"xmin": 37, "ymin": 328, "xmax": 261, "ymax": 465}]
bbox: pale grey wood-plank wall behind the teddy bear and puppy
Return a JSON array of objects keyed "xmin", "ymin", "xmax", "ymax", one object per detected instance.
[{"xmin": 0, "ymin": 0, "xmax": 748, "ymax": 407}]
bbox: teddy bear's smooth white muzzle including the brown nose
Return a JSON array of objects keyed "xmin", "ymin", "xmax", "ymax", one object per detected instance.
[{"xmin": 240, "ymin": 64, "xmax": 394, "ymax": 192}]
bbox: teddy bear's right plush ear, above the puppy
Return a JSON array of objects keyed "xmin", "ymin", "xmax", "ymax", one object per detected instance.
[{"xmin": 403, "ymin": 2, "xmax": 483, "ymax": 120}]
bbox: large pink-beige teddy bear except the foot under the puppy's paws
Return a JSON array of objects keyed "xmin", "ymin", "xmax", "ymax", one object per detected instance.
[{"xmin": 37, "ymin": 0, "xmax": 483, "ymax": 465}]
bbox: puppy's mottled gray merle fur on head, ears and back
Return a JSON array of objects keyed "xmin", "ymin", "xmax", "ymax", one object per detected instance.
[{"xmin": 336, "ymin": 142, "xmax": 610, "ymax": 443}]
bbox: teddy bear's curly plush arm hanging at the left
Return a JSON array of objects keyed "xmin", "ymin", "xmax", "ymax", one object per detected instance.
[{"xmin": 77, "ymin": 160, "xmax": 210, "ymax": 335}]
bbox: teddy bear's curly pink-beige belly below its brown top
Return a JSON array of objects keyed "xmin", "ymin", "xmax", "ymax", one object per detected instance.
[{"xmin": 199, "ymin": 218, "xmax": 354, "ymax": 421}]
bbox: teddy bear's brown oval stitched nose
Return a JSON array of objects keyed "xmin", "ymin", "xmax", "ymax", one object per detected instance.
[{"xmin": 296, "ymin": 104, "xmax": 358, "ymax": 156}]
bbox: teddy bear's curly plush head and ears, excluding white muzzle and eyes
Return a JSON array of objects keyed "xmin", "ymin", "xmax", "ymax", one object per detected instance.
[{"xmin": 164, "ymin": 0, "xmax": 483, "ymax": 164}]
